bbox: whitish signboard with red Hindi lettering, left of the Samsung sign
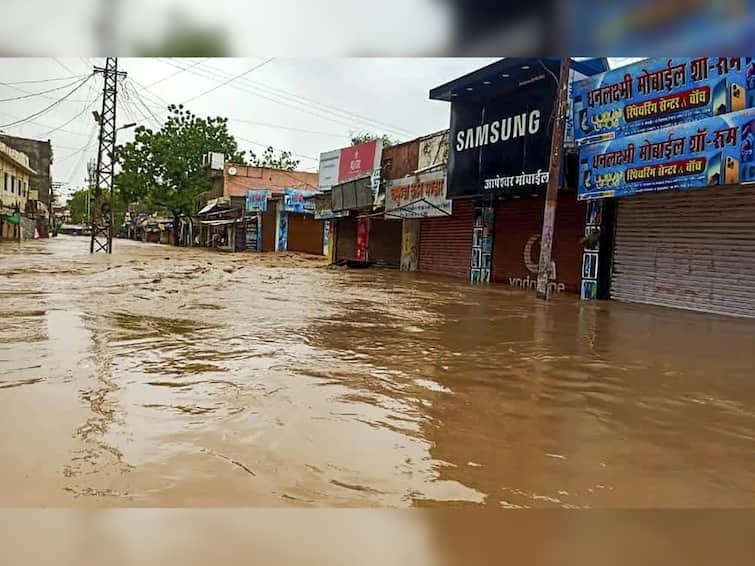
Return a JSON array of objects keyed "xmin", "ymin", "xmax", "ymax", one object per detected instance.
[{"xmin": 385, "ymin": 171, "xmax": 452, "ymax": 218}]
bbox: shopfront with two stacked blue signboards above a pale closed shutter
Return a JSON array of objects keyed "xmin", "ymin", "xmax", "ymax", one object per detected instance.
[{"xmin": 575, "ymin": 57, "xmax": 755, "ymax": 317}]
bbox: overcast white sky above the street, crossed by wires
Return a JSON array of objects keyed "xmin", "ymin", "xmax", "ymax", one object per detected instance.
[{"xmin": 0, "ymin": 57, "xmax": 508, "ymax": 200}]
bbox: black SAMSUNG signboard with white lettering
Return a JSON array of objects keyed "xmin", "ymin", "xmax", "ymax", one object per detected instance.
[{"xmin": 447, "ymin": 62, "xmax": 559, "ymax": 198}]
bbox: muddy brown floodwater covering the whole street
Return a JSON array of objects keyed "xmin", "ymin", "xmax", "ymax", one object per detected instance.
[{"xmin": 0, "ymin": 236, "xmax": 755, "ymax": 508}]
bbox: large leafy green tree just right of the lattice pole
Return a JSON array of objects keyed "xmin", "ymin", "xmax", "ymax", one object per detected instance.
[{"xmin": 115, "ymin": 105, "xmax": 245, "ymax": 243}]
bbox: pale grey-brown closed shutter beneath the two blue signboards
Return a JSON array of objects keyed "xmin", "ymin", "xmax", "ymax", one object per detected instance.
[{"xmin": 611, "ymin": 187, "xmax": 755, "ymax": 317}]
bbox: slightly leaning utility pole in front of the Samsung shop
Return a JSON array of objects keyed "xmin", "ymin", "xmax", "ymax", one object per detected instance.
[{"xmin": 537, "ymin": 57, "xmax": 571, "ymax": 300}]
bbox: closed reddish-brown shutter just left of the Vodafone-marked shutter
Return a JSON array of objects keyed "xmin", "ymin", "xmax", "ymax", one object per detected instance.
[{"xmin": 419, "ymin": 199, "xmax": 473, "ymax": 278}]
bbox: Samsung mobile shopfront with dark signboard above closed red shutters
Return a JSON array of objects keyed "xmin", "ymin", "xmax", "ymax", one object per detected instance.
[{"xmin": 420, "ymin": 58, "xmax": 604, "ymax": 293}]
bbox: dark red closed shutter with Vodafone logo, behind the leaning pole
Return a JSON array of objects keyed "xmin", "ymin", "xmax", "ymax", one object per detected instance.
[{"xmin": 492, "ymin": 191, "xmax": 586, "ymax": 293}]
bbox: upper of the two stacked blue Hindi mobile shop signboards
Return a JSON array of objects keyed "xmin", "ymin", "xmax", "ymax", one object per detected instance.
[{"xmin": 572, "ymin": 57, "xmax": 755, "ymax": 145}]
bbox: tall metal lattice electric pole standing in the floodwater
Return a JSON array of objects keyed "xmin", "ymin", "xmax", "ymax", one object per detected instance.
[{"xmin": 89, "ymin": 57, "xmax": 126, "ymax": 253}]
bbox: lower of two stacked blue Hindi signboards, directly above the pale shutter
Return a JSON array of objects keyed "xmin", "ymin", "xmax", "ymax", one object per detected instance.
[{"xmin": 578, "ymin": 109, "xmax": 755, "ymax": 200}]
